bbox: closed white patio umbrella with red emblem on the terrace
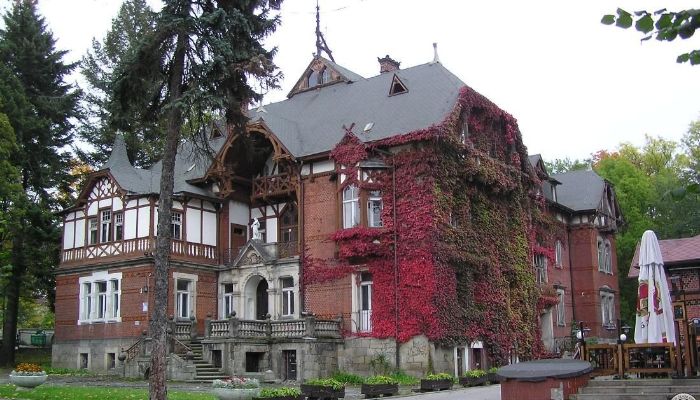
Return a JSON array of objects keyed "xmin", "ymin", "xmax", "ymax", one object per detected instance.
[{"xmin": 634, "ymin": 231, "xmax": 676, "ymax": 344}]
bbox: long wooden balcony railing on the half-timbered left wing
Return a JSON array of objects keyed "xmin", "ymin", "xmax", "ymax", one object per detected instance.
[{"xmin": 61, "ymin": 238, "xmax": 219, "ymax": 266}]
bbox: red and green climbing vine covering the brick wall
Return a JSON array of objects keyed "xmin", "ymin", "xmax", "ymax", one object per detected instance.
[{"xmin": 305, "ymin": 87, "xmax": 561, "ymax": 362}]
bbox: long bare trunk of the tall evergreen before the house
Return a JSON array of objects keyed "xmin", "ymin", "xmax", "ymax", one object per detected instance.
[{"xmin": 149, "ymin": 33, "xmax": 187, "ymax": 400}]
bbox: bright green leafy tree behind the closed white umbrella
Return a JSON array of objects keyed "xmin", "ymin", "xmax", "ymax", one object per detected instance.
[{"xmin": 594, "ymin": 133, "xmax": 700, "ymax": 321}]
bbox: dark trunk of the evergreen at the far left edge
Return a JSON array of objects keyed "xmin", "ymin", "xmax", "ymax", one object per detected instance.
[{"xmin": 0, "ymin": 232, "xmax": 27, "ymax": 367}]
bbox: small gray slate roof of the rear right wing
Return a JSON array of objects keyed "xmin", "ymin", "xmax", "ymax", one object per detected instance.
[{"xmin": 552, "ymin": 171, "xmax": 605, "ymax": 211}]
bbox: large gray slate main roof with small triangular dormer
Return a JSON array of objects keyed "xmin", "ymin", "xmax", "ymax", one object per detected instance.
[{"xmin": 250, "ymin": 63, "xmax": 465, "ymax": 157}]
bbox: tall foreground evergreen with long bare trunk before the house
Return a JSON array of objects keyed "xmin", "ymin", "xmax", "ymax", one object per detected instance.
[{"xmin": 113, "ymin": 0, "xmax": 281, "ymax": 400}]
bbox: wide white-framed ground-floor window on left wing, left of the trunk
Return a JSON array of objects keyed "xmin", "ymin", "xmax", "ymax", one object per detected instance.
[{"xmin": 78, "ymin": 271, "xmax": 122, "ymax": 325}]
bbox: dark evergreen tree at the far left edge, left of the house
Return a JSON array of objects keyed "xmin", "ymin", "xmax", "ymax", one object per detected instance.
[{"xmin": 0, "ymin": 0, "xmax": 80, "ymax": 365}]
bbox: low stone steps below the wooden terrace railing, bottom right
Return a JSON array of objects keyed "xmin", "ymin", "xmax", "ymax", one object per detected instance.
[{"xmin": 569, "ymin": 379, "xmax": 700, "ymax": 400}]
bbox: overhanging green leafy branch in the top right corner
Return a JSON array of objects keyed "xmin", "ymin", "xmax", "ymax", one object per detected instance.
[{"xmin": 600, "ymin": 8, "xmax": 700, "ymax": 65}]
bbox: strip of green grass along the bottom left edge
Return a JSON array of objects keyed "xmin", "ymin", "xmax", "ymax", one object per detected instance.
[{"xmin": 0, "ymin": 385, "xmax": 216, "ymax": 400}]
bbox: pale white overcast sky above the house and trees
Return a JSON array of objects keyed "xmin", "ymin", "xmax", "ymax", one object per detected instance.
[{"xmin": 5, "ymin": 0, "xmax": 700, "ymax": 160}]
